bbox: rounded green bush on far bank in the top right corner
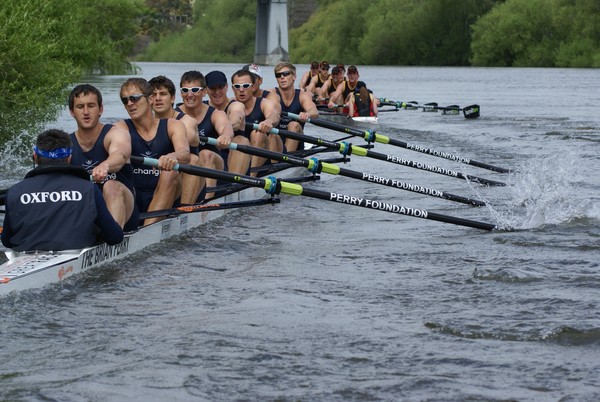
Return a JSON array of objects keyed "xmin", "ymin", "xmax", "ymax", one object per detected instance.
[{"xmin": 471, "ymin": 0, "xmax": 600, "ymax": 67}]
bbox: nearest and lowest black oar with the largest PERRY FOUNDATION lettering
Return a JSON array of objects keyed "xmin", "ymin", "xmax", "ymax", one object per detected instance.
[{"xmin": 131, "ymin": 156, "xmax": 498, "ymax": 230}]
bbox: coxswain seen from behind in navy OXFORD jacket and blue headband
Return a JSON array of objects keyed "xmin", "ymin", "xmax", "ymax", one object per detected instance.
[{"xmin": 2, "ymin": 130, "xmax": 123, "ymax": 251}]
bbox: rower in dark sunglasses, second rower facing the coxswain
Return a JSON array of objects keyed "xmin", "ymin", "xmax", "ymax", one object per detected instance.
[{"xmin": 116, "ymin": 78, "xmax": 190, "ymax": 225}]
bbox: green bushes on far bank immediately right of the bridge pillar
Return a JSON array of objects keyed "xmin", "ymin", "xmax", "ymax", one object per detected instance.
[{"xmin": 290, "ymin": 0, "xmax": 494, "ymax": 65}]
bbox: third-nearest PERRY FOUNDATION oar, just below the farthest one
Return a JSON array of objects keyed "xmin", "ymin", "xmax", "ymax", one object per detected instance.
[{"xmin": 256, "ymin": 123, "xmax": 506, "ymax": 186}]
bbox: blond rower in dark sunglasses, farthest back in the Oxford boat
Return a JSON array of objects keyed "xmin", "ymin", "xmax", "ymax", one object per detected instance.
[{"xmin": 271, "ymin": 62, "xmax": 319, "ymax": 152}]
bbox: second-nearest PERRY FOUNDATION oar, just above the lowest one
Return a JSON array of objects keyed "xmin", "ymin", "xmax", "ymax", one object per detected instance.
[{"xmin": 200, "ymin": 136, "xmax": 485, "ymax": 207}]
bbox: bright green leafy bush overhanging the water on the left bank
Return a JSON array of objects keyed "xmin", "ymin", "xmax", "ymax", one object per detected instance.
[{"xmin": 0, "ymin": 0, "xmax": 139, "ymax": 148}]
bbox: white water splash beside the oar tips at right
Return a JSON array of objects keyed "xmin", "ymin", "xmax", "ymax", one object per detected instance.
[{"xmin": 488, "ymin": 153, "xmax": 600, "ymax": 230}]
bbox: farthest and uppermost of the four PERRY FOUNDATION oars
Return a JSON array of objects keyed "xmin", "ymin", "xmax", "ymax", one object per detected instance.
[{"xmin": 281, "ymin": 112, "xmax": 510, "ymax": 173}]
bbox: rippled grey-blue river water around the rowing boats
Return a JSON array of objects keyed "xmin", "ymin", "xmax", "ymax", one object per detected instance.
[{"xmin": 0, "ymin": 63, "xmax": 600, "ymax": 401}]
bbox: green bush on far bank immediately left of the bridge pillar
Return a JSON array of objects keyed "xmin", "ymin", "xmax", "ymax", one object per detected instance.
[{"xmin": 138, "ymin": 0, "xmax": 256, "ymax": 63}]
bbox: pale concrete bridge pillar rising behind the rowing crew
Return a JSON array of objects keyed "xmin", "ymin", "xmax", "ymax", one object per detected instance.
[{"xmin": 254, "ymin": 0, "xmax": 290, "ymax": 66}]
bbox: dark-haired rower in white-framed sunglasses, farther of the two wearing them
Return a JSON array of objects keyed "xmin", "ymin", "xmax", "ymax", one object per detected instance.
[{"xmin": 231, "ymin": 70, "xmax": 283, "ymax": 175}]
